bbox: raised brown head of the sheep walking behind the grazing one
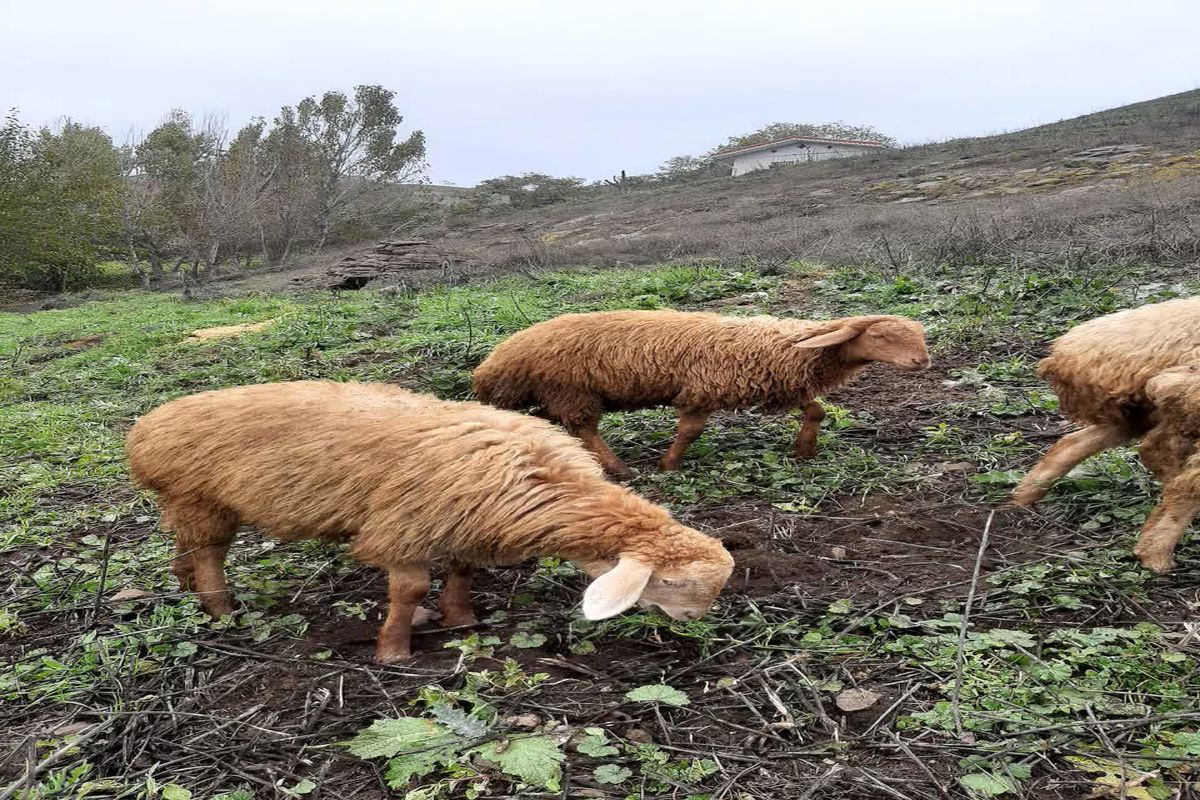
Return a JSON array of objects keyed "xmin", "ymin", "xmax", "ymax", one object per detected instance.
[{"xmin": 796, "ymin": 317, "xmax": 929, "ymax": 372}]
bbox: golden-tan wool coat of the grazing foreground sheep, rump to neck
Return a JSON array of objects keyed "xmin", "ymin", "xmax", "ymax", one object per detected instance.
[{"xmin": 127, "ymin": 381, "xmax": 728, "ymax": 567}]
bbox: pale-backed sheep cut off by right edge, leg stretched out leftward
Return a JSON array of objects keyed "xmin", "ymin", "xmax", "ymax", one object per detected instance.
[{"xmin": 1012, "ymin": 297, "xmax": 1200, "ymax": 507}]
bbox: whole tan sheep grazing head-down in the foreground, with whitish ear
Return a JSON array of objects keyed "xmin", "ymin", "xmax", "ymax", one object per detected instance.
[{"xmin": 126, "ymin": 381, "xmax": 733, "ymax": 663}]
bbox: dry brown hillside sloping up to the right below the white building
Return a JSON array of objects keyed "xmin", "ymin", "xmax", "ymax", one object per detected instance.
[{"xmin": 288, "ymin": 90, "xmax": 1200, "ymax": 291}]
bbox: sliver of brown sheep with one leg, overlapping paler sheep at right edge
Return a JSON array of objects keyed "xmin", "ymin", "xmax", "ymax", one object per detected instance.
[{"xmin": 1134, "ymin": 365, "xmax": 1200, "ymax": 572}]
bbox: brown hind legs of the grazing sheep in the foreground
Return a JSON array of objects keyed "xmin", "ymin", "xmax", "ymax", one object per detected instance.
[{"xmin": 163, "ymin": 500, "xmax": 238, "ymax": 619}]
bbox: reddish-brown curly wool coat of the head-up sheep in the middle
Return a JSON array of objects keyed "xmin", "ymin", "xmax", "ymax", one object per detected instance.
[{"xmin": 474, "ymin": 311, "xmax": 911, "ymax": 425}]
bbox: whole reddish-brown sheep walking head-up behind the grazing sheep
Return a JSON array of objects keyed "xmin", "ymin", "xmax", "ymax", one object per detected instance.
[{"xmin": 474, "ymin": 311, "xmax": 929, "ymax": 477}]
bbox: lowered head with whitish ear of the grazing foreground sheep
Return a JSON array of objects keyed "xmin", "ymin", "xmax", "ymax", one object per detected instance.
[{"xmin": 580, "ymin": 530, "xmax": 733, "ymax": 620}]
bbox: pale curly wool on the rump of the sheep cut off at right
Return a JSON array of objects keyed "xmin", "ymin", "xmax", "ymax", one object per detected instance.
[{"xmin": 1038, "ymin": 297, "xmax": 1200, "ymax": 434}]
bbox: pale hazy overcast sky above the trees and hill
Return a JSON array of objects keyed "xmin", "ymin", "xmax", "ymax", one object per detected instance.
[{"xmin": 0, "ymin": 0, "xmax": 1200, "ymax": 185}]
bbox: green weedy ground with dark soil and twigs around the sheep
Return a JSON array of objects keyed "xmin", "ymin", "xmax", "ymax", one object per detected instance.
[{"xmin": 0, "ymin": 264, "xmax": 1200, "ymax": 800}]
